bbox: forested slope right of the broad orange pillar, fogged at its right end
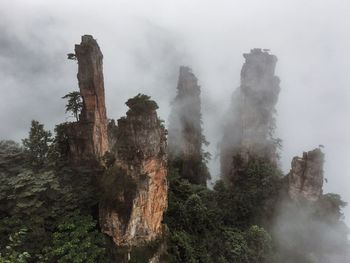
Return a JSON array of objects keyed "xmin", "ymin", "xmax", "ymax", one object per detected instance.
[{"xmin": 165, "ymin": 159, "xmax": 349, "ymax": 263}]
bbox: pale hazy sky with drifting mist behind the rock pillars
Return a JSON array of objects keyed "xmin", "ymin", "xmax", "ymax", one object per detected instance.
[{"xmin": 0, "ymin": 0, "xmax": 350, "ymax": 223}]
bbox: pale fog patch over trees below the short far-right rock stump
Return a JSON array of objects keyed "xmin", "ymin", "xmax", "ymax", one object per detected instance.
[{"xmin": 272, "ymin": 199, "xmax": 350, "ymax": 263}]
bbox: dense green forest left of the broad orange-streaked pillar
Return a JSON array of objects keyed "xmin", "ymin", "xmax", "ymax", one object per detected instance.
[{"xmin": 0, "ymin": 124, "xmax": 105, "ymax": 263}]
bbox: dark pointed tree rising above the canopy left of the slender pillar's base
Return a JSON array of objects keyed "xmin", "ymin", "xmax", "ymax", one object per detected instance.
[{"xmin": 22, "ymin": 120, "xmax": 52, "ymax": 168}]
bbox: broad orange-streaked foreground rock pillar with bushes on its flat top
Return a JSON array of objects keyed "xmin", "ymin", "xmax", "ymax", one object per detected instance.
[{"xmin": 100, "ymin": 95, "xmax": 167, "ymax": 249}]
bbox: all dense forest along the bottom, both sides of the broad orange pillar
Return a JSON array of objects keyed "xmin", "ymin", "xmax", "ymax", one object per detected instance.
[{"xmin": 0, "ymin": 119, "xmax": 348, "ymax": 263}]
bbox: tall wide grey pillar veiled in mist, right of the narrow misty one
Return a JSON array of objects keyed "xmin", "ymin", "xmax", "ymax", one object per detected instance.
[{"xmin": 221, "ymin": 49, "xmax": 280, "ymax": 186}]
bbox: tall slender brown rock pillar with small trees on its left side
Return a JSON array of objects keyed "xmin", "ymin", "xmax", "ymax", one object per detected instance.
[{"xmin": 66, "ymin": 35, "xmax": 108, "ymax": 160}]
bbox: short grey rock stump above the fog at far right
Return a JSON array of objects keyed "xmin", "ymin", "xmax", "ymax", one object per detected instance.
[{"xmin": 288, "ymin": 148, "xmax": 324, "ymax": 201}]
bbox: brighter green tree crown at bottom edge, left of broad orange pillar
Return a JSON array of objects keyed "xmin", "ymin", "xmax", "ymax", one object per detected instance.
[{"xmin": 43, "ymin": 211, "xmax": 105, "ymax": 263}]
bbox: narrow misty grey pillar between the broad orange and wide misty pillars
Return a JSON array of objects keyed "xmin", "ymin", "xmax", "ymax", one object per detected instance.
[{"xmin": 168, "ymin": 66, "xmax": 208, "ymax": 185}]
